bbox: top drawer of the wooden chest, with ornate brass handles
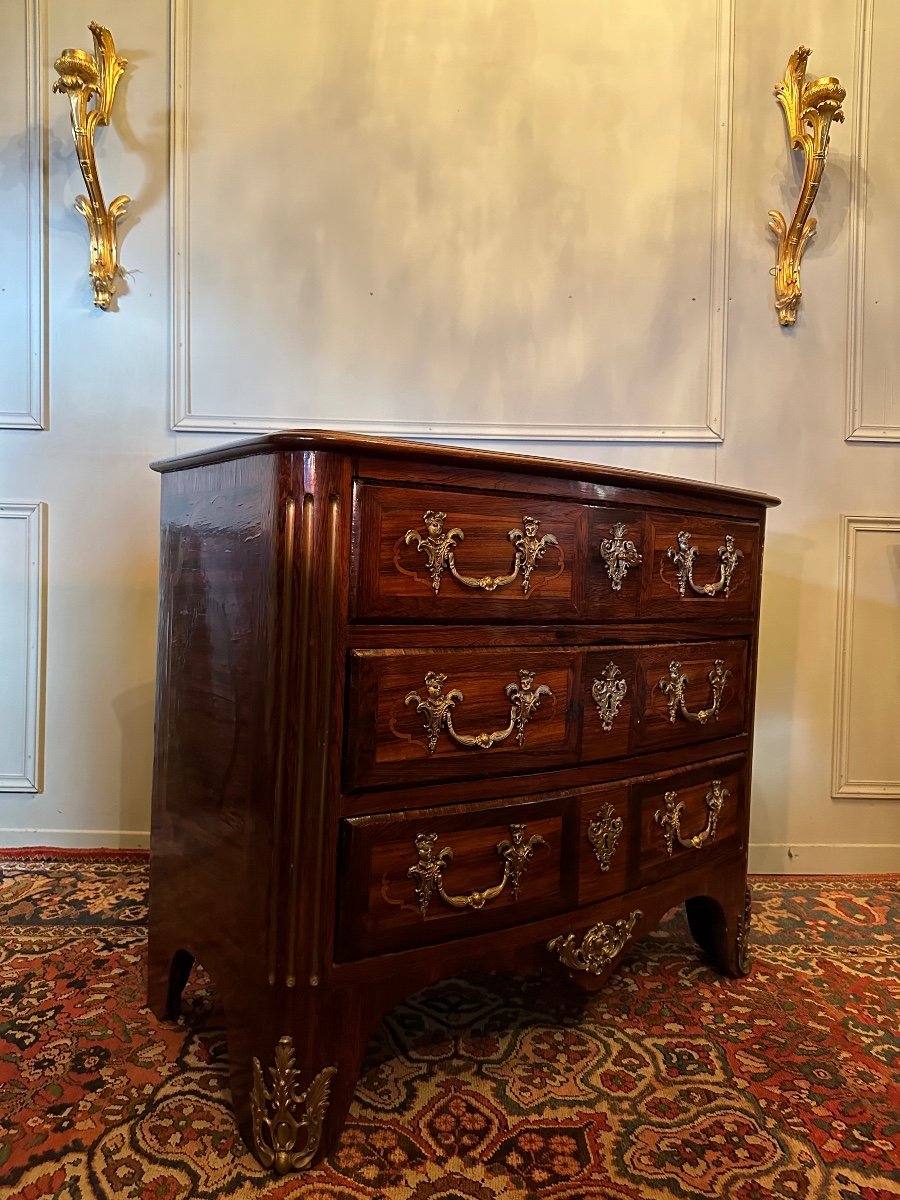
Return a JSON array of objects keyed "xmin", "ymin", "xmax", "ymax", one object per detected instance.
[{"xmin": 350, "ymin": 484, "xmax": 761, "ymax": 623}]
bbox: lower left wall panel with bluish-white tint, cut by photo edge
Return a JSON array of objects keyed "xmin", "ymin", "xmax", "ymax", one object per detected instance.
[{"xmin": 0, "ymin": 504, "xmax": 46, "ymax": 792}]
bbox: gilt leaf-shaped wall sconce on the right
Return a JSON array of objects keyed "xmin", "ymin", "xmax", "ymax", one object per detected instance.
[{"xmin": 769, "ymin": 46, "xmax": 846, "ymax": 325}]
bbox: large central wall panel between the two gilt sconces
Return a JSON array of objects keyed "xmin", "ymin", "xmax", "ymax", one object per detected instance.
[{"xmin": 172, "ymin": 0, "xmax": 733, "ymax": 442}]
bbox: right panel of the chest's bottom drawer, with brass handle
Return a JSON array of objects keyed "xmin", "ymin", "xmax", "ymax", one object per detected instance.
[{"xmin": 632, "ymin": 760, "xmax": 748, "ymax": 882}]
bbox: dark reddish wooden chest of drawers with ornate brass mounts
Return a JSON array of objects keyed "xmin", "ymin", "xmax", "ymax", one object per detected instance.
[{"xmin": 149, "ymin": 432, "xmax": 776, "ymax": 1171}]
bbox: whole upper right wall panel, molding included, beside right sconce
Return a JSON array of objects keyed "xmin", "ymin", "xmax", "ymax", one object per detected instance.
[{"xmin": 847, "ymin": 0, "xmax": 900, "ymax": 442}]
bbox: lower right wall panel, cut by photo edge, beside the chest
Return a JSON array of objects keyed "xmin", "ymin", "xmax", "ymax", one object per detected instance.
[{"xmin": 833, "ymin": 516, "xmax": 900, "ymax": 798}]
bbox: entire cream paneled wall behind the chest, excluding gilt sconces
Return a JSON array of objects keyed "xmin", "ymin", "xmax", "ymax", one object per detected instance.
[{"xmin": 0, "ymin": 0, "xmax": 900, "ymax": 871}]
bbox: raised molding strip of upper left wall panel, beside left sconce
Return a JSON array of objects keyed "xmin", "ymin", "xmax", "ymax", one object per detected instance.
[{"xmin": 0, "ymin": 0, "xmax": 48, "ymax": 430}]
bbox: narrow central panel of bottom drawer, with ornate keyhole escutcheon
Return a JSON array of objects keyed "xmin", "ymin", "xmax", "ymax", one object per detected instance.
[{"xmin": 578, "ymin": 784, "xmax": 632, "ymax": 904}]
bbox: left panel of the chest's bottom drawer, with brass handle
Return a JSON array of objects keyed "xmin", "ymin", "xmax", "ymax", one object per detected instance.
[{"xmin": 337, "ymin": 799, "xmax": 570, "ymax": 958}]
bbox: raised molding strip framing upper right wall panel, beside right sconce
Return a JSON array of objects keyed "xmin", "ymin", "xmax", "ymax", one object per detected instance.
[{"xmin": 846, "ymin": 0, "xmax": 900, "ymax": 442}]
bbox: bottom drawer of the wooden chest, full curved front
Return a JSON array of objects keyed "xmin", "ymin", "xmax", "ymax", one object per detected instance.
[{"xmin": 336, "ymin": 756, "xmax": 748, "ymax": 961}]
